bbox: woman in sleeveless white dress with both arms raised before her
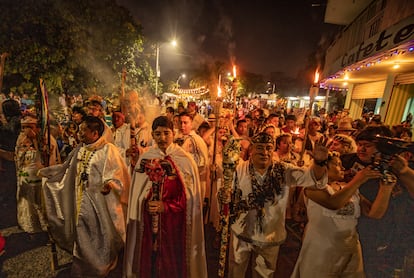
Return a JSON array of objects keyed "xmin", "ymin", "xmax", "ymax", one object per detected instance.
[{"xmin": 291, "ymin": 153, "xmax": 395, "ymax": 278}]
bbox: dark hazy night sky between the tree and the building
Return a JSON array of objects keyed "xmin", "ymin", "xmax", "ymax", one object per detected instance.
[{"xmin": 117, "ymin": 0, "xmax": 338, "ymax": 80}]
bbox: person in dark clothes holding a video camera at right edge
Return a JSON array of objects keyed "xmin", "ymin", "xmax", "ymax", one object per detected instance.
[{"xmin": 341, "ymin": 126, "xmax": 414, "ymax": 277}]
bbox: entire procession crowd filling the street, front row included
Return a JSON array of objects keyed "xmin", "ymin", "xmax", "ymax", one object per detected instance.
[{"xmin": 0, "ymin": 91, "xmax": 414, "ymax": 277}]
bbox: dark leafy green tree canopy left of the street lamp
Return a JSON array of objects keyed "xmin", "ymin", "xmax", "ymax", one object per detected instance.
[{"xmin": 0, "ymin": 0, "xmax": 155, "ymax": 95}]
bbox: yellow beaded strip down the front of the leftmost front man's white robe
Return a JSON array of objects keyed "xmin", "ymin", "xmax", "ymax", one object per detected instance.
[{"xmin": 76, "ymin": 148, "xmax": 96, "ymax": 223}]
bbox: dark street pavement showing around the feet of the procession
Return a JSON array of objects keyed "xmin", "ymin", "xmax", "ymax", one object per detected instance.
[{"xmin": 0, "ymin": 161, "xmax": 300, "ymax": 278}]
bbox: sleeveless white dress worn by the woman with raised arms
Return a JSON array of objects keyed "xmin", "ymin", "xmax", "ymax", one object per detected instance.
[{"xmin": 291, "ymin": 185, "xmax": 365, "ymax": 278}]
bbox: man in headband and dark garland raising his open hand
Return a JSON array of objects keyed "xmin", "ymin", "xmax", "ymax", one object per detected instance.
[{"xmin": 219, "ymin": 132, "xmax": 328, "ymax": 277}]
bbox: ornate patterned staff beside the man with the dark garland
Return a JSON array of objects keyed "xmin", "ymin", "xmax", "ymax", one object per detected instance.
[{"xmin": 218, "ymin": 136, "xmax": 240, "ymax": 278}]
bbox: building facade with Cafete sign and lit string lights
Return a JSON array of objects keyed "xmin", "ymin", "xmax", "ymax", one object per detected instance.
[{"xmin": 320, "ymin": 0, "xmax": 414, "ymax": 125}]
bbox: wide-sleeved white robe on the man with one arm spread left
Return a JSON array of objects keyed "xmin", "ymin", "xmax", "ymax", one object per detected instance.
[{"xmin": 40, "ymin": 137, "xmax": 130, "ymax": 277}]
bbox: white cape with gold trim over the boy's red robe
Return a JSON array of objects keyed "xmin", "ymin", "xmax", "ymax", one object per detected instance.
[{"xmin": 123, "ymin": 144, "xmax": 207, "ymax": 278}]
